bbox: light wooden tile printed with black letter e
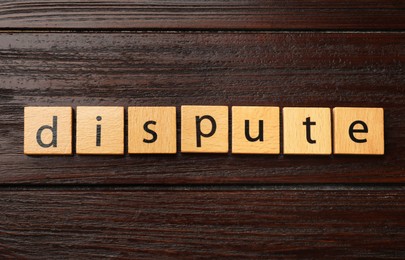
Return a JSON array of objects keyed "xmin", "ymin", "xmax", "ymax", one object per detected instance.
[{"xmin": 333, "ymin": 107, "xmax": 384, "ymax": 155}]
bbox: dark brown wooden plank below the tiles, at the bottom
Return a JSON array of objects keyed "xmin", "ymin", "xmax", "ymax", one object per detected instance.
[{"xmin": 0, "ymin": 190, "xmax": 405, "ymax": 259}]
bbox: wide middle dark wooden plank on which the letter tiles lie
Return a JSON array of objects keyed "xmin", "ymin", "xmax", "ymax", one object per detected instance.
[{"xmin": 0, "ymin": 32, "xmax": 405, "ymax": 184}]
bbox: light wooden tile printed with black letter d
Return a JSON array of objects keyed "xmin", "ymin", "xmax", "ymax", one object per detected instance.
[{"xmin": 24, "ymin": 107, "xmax": 72, "ymax": 155}]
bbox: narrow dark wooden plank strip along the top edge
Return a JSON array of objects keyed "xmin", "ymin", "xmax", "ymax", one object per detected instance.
[{"xmin": 0, "ymin": 0, "xmax": 405, "ymax": 30}]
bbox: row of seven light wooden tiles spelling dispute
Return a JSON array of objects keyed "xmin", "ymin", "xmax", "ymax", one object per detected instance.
[{"xmin": 24, "ymin": 105, "xmax": 384, "ymax": 155}]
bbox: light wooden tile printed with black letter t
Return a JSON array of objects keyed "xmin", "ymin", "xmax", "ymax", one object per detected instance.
[{"xmin": 283, "ymin": 107, "xmax": 332, "ymax": 154}]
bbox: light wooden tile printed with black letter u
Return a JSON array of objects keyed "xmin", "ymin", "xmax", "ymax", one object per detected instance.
[{"xmin": 232, "ymin": 106, "xmax": 280, "ymax": 154}]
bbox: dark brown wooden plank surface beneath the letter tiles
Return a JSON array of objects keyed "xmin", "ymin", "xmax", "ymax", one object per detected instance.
[{"xmin": 0, "ymin": 0, "xmax": 405, "ymax": 259}]
